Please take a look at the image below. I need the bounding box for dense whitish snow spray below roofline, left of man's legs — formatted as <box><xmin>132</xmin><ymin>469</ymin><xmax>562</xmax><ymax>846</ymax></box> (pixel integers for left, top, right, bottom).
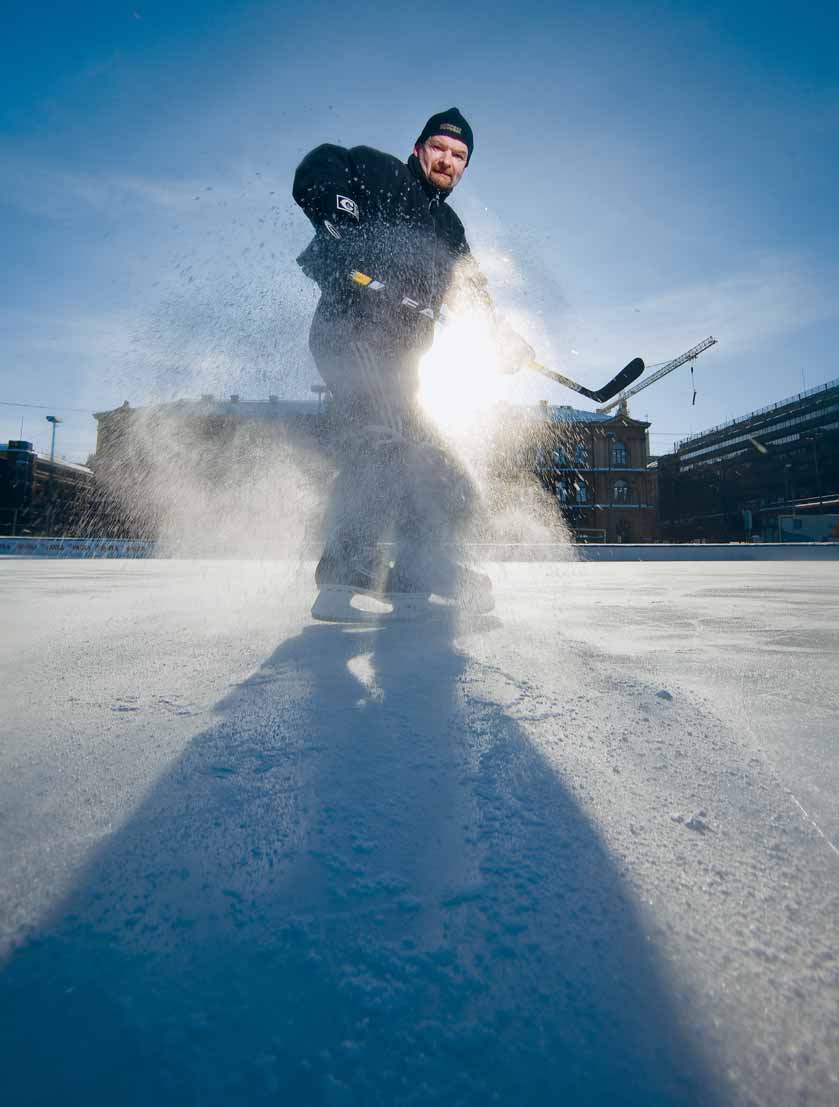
<box><xmin>90</xmin><ymin>400</ymin><xmax>323</xmax><ymax>558</ymax></box>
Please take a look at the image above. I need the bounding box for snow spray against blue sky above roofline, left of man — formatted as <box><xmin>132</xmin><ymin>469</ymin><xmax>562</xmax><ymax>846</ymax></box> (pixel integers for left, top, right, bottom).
<box><xmin>115</xmin><ymin>174</ymin><xmax>317</xmax><ymax>414</ymax></box>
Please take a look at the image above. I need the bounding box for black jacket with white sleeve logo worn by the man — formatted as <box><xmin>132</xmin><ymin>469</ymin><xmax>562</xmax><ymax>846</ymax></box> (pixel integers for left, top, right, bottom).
<box><xmin>293</xmin><ymin>144</ymin><xmax>485</xmax><ymax>352</ymax></box>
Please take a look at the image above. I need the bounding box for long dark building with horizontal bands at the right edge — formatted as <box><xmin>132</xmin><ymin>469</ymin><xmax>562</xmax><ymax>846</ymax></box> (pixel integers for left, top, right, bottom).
<box><xmin>657</xmin><ymin>381</ymin><xmax>839</xmax><ymax>541</ymax></box>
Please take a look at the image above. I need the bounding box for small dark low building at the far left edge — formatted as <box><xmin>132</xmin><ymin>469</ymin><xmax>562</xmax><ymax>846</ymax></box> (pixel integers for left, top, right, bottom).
<box><xmin>0</xmin><ymin>439</ymin><xmax>93</xmax><ymax>537</ymax></box>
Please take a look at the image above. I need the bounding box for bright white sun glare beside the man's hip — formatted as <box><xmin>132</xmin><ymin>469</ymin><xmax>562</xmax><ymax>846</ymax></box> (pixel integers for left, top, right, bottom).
<box><xmin>420</xmin><ymin>317</ymin><xmax>504</xmax><ymax>431</ymax></box>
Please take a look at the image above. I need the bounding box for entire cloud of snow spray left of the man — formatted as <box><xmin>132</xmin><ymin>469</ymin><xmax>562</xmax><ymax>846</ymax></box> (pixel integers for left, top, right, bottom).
<box><xmin>80</xmin><ymin>172</ymin><xmax>332</xmax><ymax>557</ymax></box>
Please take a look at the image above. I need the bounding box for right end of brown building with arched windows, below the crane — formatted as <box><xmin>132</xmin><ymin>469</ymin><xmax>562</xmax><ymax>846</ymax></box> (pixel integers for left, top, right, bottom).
<box><xmin>534</xmin><ymin>404</ymin><xmax>657</xmax><ymax>542</ymax></box>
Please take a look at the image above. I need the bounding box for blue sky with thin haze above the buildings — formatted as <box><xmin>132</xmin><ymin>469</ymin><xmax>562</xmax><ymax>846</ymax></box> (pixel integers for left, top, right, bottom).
<box><xmin>0</xmin><ymin>0</ymin><xmax>839</xmax><ymax>459</ymax></box>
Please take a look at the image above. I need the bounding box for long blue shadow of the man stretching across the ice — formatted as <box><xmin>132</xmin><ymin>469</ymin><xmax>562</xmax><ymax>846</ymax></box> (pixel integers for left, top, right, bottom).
<box><xmin>2</xmin><ymin>620</ymin><xmax>716</xmax><ymax>1107</ymax></box>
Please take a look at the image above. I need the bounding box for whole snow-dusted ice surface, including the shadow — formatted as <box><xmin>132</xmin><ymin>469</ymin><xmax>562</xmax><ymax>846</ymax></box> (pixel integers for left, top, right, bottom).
<box><xmin>0</xmin><ymin>560</ymin><xmax>839</xmax><ymax>1107</ymax></box>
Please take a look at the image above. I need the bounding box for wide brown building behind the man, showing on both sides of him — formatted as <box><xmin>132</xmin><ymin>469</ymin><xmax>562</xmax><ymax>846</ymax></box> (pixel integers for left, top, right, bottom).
<box><xmin>91</xmin><ymin>389</ymin><xmax>656</xmax><ymax>541</ymax></box>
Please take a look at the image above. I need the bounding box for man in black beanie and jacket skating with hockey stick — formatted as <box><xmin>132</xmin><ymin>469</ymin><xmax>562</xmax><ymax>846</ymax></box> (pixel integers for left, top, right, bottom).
<box><xmin>293</xmin><ymin>107</ymin><xmax>534</xmax><ymax>619</ymax></box>
